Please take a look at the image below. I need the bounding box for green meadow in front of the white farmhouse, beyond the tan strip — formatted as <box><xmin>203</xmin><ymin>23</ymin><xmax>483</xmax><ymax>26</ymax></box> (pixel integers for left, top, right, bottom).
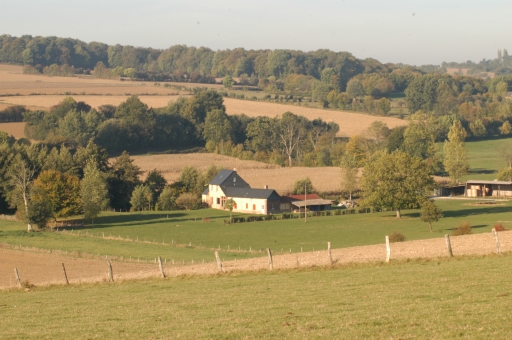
<box><xmin>0</xmin><ymin>200</ymin><xmax>512</xmax><ymax>261</ymax></box>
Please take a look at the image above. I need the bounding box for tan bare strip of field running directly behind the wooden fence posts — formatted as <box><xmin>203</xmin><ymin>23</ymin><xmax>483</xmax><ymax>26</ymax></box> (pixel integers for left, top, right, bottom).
<box><xmin>0</xmin><ymin>231</ymin><xmax>512</xmax><ymax>289</ymax></box>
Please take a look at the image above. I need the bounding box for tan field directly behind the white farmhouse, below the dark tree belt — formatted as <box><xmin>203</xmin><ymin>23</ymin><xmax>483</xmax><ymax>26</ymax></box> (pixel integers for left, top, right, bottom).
<box><xmin>126</xmin><ymin>153</ymin><xmax>341</xmax><ymax>194</ymax></box>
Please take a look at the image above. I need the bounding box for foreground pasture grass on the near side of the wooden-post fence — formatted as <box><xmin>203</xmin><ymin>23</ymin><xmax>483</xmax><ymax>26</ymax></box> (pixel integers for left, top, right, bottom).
<box><xmin>0</xmin><ymin>254</ymin><xmax>512</xmax><ymax>339</ymax></box>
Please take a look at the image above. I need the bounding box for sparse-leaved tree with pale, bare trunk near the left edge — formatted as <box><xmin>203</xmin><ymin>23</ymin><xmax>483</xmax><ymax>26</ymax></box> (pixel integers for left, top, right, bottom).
<box><xmin>8</xmin><ymin>159</ymin><xmax>36</xmax><ymax>232</ymax></box>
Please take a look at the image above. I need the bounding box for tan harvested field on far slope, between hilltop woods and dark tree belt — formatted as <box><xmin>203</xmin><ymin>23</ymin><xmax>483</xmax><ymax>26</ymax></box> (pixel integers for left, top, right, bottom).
<box><xmin>0</xmin><ymin>65</ymin><xmax>407</xmax><ymax>137</ymax></box>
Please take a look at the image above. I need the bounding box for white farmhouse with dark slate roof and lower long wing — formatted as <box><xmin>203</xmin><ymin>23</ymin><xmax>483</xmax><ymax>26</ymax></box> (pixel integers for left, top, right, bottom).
<box><xmin>202</xmin><ymin>170</ymin><xmax>280</xmax><ymax>215</ymax></box>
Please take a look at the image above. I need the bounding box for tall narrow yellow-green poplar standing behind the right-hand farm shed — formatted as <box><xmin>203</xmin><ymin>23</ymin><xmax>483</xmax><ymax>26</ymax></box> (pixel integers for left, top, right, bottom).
<box><xmin>443</xmin><ymin>120</ymin><xmax>469</xmax><ymax>183</ymax></box>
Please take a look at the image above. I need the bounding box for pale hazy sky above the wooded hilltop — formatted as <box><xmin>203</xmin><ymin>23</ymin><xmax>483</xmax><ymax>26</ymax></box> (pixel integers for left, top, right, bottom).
<box><xmin>0</xmin><ymin>0</ymin><xmax>512</xmax><ymax>65</ymax></box>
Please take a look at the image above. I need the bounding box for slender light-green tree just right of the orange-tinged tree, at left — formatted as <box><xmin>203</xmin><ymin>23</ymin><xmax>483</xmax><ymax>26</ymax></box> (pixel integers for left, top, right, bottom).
<box><xmin>80</xmin><ymin>158</ymin><xmax>108</xmax><ymax>226</ymax></box>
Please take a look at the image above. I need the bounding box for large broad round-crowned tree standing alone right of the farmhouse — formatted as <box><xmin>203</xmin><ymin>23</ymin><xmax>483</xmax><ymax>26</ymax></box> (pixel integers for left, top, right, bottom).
<box><xmin>360</xmin><ymin>151</ymin><xmax>435</xmax><ymax>218</ymax></box>
